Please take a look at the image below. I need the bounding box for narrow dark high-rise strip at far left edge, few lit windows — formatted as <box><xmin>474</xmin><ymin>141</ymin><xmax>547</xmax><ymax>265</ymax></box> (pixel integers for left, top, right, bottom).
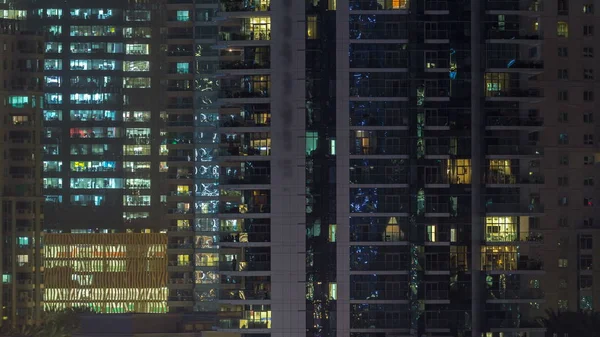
<box><xmin>0</xmin><ymin>5</ymin><xmax>44</xmax><ymax>328</ymax></box>
